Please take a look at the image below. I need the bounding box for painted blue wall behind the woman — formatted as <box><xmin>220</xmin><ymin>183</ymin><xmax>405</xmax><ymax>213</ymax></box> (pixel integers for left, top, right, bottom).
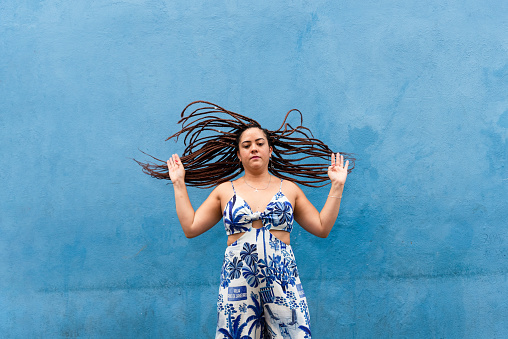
<box><xmin>0</xmin><ymin>0</ymin><xmax>508</xmax><ymax>338</ymax></box>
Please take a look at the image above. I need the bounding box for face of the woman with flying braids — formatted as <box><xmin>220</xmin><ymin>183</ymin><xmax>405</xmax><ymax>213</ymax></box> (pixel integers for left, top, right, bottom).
<box><xmin>237</xmin><ymin>127</ymin><xmax>272</xmax><ymax>169</ymax></box>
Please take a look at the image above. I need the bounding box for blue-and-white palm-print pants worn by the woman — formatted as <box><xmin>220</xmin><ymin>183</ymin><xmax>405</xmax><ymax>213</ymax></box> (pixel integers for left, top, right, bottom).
<box><xmin>215</xmin><ymin>227</ymin><xmax>311</xmax><ymax>339</ymax></box>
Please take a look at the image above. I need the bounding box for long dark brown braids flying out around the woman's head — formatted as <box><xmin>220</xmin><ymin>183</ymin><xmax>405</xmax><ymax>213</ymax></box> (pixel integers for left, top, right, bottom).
<box><xmin>135</xmin><ymin>101</ymin><xmax>356</xmax><ymax>188</ymax></box>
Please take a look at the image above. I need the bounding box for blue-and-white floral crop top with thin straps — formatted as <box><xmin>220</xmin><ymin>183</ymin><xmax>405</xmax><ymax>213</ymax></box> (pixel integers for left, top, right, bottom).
<box><xmin>222</xmin><ymin>179</ymin><xmax>293</xmax><ymax>235</ymax></box>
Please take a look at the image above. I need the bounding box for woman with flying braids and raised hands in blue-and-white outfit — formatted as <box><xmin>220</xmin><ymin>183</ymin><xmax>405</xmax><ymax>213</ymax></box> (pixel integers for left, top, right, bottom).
<box><xmin>141</xmin><ymin>102</ymin><xmax>354</xmax><ymax>339</ymax></box>
